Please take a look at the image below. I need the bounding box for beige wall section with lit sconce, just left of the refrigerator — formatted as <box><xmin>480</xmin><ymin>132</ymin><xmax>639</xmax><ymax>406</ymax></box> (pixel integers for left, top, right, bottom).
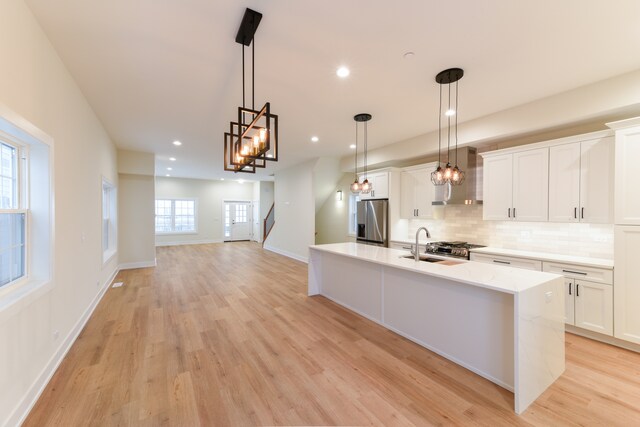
<box><xmin>316</xmin><ymin>173</ymin><xmax>355</xmax><ymax>245</ymax></box>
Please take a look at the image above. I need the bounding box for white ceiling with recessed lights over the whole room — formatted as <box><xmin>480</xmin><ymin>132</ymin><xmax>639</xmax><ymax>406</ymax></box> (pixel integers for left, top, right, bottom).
<box><xmin>26</xmin><ymin>0</ymin><xmax>640</xmax><ymax>179</ymax></box>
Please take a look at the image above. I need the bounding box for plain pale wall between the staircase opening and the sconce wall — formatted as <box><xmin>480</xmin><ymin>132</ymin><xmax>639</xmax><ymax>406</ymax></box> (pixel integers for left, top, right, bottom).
<box><xmin>264</xmin><ymin>160</ymin><xmax>316</xmax><ymax>262</ymax></box>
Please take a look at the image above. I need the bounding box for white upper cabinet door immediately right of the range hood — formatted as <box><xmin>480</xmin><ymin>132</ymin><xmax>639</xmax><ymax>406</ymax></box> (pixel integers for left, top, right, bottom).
<box><xmin>482</xmin><ymin>154</ymin><xmax>513</xmax><ymax>220</ymax></box>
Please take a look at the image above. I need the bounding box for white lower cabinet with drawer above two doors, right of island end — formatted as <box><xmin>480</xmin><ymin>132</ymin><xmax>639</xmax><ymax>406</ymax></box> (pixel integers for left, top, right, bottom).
<box><xmin>542</xmin><ymin>262</ymin><xmax>613</xmax><ymax>336</ymax></box>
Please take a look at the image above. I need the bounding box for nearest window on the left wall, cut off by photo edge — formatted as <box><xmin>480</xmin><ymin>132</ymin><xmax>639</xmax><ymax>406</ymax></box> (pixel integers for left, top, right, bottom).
<box><xmin>0</xmin><ymin>141</ymin><xmax>27</xmax><ymax>287</ymax></box>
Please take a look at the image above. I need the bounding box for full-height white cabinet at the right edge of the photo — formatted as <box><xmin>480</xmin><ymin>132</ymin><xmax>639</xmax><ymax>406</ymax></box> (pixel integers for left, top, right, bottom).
<box><xmin>607</xmin><ymin>117</ymin><xmax>640</xmax><ymax>344</ymax></box>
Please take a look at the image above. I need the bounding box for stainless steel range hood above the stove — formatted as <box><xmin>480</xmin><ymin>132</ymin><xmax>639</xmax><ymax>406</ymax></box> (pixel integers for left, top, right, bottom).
<box><xmin>432</xmin><ymin>147</ymin><xmax>482</xmax><ymax>206</ymax></box>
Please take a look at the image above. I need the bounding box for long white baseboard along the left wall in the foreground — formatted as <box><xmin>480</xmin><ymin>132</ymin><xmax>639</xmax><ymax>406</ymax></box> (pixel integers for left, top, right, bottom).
<box><xmin>5</xmin><ymin>268</ymin><xmax>119</xmax><ymax>426</ymax></box>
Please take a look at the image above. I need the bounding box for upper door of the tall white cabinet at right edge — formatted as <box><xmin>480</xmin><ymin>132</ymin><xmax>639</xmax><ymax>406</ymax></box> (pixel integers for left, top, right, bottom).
<box><xmin>615</xmin><ymin>126</ymin><xmax>640</xmax><ymax>225</ymax></box>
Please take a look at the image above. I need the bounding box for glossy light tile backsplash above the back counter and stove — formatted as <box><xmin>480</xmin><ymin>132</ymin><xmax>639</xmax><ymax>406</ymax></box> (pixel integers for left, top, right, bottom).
<box><xmin>407</xmin><ymin>205</ymin><xmax>613</xmax><ymax>259</ymax></box>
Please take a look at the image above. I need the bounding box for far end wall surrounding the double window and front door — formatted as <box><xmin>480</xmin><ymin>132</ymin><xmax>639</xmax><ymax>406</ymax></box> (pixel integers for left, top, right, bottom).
<box><xmin>155</xmin><ymin>177</ymin><xmax>253</xmax><ymax>246</ymax></box>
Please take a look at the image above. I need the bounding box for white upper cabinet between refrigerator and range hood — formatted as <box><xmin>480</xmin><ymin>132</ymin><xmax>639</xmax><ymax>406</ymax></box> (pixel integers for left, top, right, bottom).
<box><xmin>400</xmin><ymin>164</ymin><xmax>435</xmax><ymax>219</ymax></box>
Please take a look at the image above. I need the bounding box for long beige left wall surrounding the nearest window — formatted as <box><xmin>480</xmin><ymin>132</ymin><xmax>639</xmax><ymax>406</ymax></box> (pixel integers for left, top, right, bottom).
<box><xmin>0</xmin><ymin>0</ymin><xmax>118</xmax><ymax>426</ymax></box>
